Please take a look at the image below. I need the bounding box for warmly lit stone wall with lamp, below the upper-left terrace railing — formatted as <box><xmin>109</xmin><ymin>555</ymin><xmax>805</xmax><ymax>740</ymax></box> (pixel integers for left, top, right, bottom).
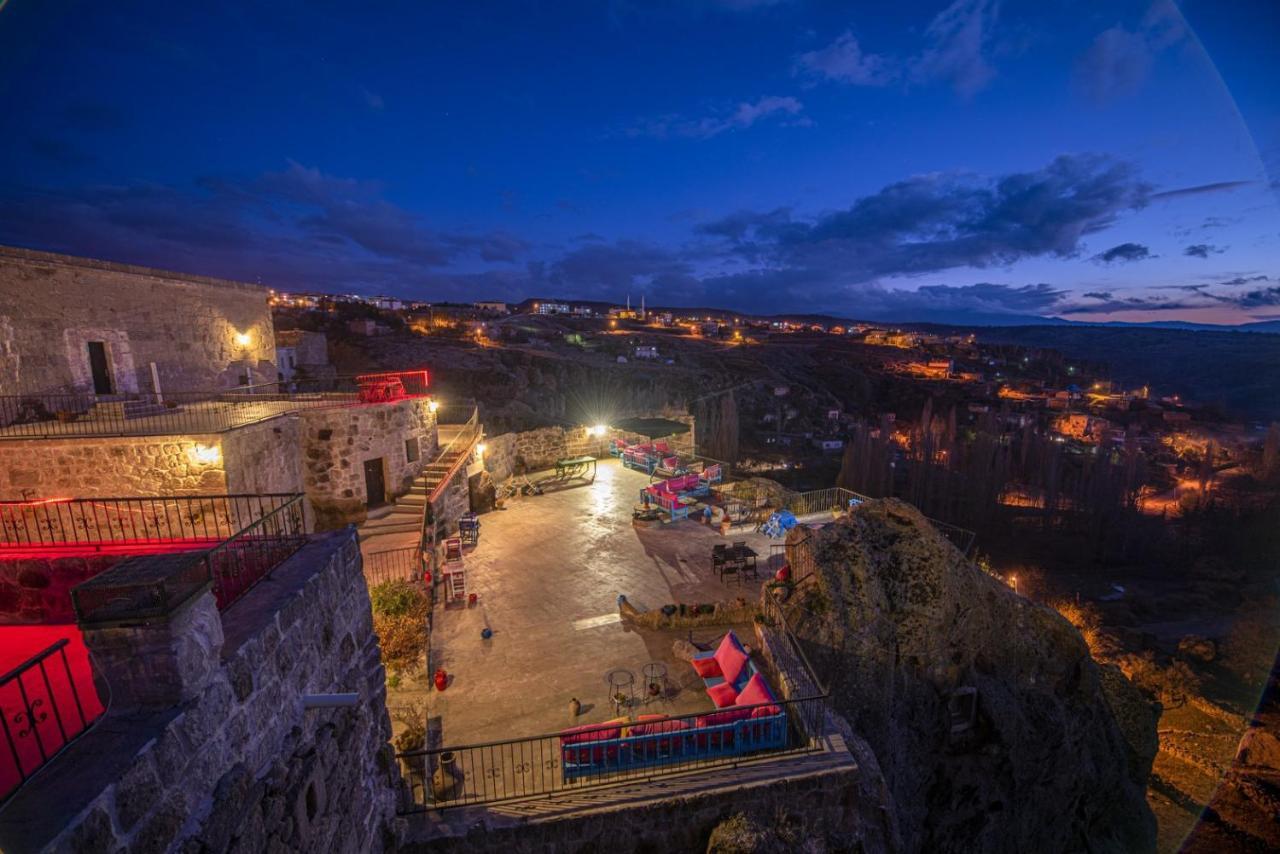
<box><xmin>0</xmin><ymin>435</ymin><xmax>227</xmax><ymax>499</ymax></box>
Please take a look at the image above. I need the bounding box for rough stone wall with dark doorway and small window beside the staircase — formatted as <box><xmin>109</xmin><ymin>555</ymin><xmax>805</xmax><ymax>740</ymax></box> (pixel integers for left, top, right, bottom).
<box><xmin>300</xmin><ymin>398</ymin><xmax>436</xmax><ymax>528</ymax></box>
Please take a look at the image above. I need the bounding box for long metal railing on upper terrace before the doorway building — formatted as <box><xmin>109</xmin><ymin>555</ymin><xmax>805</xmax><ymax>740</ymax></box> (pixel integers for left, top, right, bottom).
<box><xmin>0</xmin><ymin>371</ymin><xmax>428</xmax><ymax>439</ymax></box>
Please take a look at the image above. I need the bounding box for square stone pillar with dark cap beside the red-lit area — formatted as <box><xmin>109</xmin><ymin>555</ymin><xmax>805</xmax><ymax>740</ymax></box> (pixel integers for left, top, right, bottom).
<box><xmin>73</xmin><ymin>553</ymin><xmax>223</xmax><ymax>713</ymax></box>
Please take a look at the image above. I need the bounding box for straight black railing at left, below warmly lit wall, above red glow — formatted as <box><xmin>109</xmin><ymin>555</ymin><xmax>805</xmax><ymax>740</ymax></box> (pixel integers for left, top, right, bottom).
<box><xmin>0</xmin><ymin>494</ymin><xmax>297</xmax><ymax>556</ymax></box>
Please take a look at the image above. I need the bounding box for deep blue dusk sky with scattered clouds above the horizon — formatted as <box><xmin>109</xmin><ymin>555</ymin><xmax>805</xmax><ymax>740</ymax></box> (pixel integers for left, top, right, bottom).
<box><xmin>0</xmin><ymin>0</ymin><xmax>1280</xmax><ymax>321</ymax></box>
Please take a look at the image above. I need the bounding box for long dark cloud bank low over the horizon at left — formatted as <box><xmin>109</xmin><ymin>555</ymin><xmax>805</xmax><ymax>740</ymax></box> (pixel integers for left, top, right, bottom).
<box><xmin>0</xmin><ymin>163</ymin><xmax>530</xmax><ymax>289</ymax></box>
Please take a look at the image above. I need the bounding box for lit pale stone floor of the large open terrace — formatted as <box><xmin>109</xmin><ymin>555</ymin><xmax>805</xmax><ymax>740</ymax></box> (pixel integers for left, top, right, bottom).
<box><xmin>428</xmin><ymin>460</ymin><xmax>780</xmax><ymax>745</ymax></box>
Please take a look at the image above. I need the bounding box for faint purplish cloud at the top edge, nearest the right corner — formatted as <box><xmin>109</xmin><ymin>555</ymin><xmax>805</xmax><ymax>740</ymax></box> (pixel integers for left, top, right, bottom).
<box><xmin>1075</xmin><ymin>0</ymin><xmax>1187</xmax><ymax>104</ymax></box>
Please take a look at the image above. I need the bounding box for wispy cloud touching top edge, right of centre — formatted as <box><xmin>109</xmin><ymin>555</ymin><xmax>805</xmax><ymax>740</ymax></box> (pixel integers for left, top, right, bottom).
<box><xmin>910</xmin><ymin>0</ymin><xmax>1000</xmax><ymax>97</ymax></box>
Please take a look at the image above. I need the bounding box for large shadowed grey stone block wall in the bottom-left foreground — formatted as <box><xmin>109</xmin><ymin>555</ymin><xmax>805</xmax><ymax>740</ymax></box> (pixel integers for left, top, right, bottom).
<box><xmin>0</xmin><ymin>529</ymin><xmax>401</xmax><ymax>853</ymax></box>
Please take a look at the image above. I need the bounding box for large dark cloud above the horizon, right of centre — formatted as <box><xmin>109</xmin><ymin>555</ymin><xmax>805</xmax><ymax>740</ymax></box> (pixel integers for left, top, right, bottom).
<box><xmin>699</xmin><ymin>155</ymin><xmax>1149</xmax><ymax>286</ymax></box>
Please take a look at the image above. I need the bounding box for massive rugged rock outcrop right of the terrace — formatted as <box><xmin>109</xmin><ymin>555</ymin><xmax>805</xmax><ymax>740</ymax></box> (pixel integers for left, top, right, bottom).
<box><xmin>787</xmin><ymin>499</ymin><xmax>1156</xmax><ymax>851</ymax></box>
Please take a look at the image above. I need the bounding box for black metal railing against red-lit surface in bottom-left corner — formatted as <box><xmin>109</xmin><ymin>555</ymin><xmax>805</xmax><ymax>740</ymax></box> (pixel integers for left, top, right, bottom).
<box><xmin>0</xmin><ymin>638</ymin><xmax>102</xmax><ymax>803</ymax></box>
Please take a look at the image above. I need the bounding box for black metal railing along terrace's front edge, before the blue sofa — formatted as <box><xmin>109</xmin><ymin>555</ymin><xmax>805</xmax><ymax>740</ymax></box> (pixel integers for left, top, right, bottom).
<box><xmin>397</xmin><ymin>695</ymin><xmax>826</xmax><ymax>812</ymax></box>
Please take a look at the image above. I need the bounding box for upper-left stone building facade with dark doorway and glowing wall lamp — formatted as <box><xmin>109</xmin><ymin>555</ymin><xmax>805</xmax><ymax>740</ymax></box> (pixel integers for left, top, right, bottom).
<box><xmin>0</xmin><ymin>247</ymin><xmax>275</xmax><ymax>394</ymax></box>
